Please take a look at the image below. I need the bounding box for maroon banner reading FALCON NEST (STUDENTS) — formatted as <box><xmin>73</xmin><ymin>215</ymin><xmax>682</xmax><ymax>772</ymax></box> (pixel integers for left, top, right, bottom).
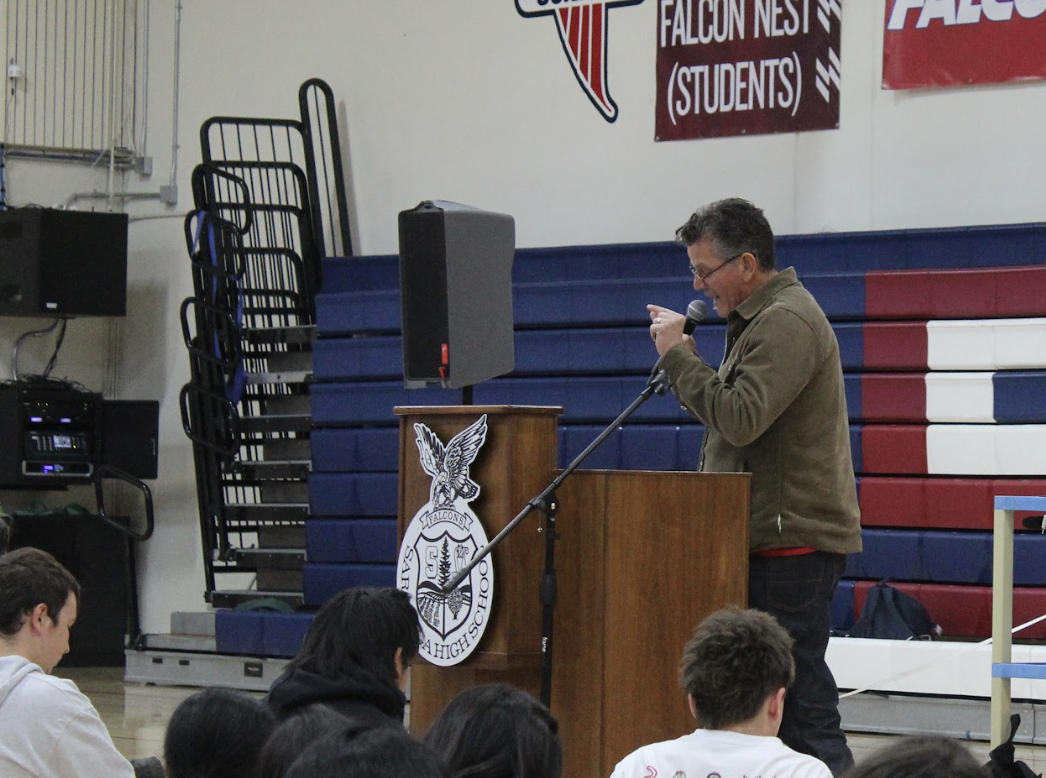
<box><xmin>654</xmin><ymin>0</ymin><xmax>842</xmax><ymax>140</ymax></box>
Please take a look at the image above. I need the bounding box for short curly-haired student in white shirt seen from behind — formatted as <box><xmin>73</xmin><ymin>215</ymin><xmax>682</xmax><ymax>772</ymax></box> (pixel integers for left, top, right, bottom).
<box><xmin>611</xmin><ymin>608</ymin><xmax>832</xmax><ymax>778</ymax></box>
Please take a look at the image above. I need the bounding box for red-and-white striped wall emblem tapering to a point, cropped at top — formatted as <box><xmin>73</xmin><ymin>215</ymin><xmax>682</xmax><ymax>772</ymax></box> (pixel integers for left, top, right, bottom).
<box><xmin>516</xmin><ymin>0</ymin><xmax>643</xmax><ymax>122</ymax></box>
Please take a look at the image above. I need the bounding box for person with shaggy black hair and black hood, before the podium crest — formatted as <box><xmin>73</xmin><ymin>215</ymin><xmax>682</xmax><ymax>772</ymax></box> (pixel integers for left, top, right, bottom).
<box><xmin>269</xmin><ymin>587</ymin><xmax>420</xmax><ymax>726</ymax></box>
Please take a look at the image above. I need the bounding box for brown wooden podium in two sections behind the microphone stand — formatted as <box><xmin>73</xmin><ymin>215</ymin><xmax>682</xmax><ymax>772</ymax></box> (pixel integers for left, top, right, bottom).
<box><xmin>395</xmin><ymin>406</ymin><xmax>749</xmax><ymax>778</ymax></box>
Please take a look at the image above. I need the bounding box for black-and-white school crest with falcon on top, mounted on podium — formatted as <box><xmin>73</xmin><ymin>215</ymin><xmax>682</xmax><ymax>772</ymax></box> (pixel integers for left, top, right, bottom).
<box><xmin>396</xmin><ymin>414</ymin><xmax>494</xmax><ymax>667</ymax></box>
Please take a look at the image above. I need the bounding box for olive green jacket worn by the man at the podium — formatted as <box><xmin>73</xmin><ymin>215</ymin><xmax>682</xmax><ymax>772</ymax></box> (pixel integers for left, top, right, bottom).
<box><xmin>661</xmin><ymin>268</ymin><xmax>861</xmax><ymax>553</ymax></box>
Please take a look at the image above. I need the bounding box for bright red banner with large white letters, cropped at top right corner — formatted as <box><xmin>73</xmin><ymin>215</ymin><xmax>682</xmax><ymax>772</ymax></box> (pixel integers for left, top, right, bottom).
<box><xmin>883</xmin><ymin>0</ymin><xmax>1046</xmax><ymax>89</ymax></box>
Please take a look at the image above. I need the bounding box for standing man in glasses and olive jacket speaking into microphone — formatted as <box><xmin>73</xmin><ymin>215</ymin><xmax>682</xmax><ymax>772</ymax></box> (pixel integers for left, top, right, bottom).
<box><xmin>646</xmin><ymin>199</ymin><xmax>861</xmax><ymax>775</ymax></box>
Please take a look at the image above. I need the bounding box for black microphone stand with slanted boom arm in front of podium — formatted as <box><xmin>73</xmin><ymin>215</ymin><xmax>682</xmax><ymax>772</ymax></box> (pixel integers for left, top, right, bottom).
<box><xmin>442</xmin><ymin>366</ymin><xmax>668</xmax><ymax>708</ymax></box>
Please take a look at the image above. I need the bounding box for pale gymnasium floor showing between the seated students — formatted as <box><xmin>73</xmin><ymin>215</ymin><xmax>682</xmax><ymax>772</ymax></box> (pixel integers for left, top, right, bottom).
<box><xmin>55</xmin><ymin>665</ymin><xmax>1046</xmax><ymax>773</ymax></box>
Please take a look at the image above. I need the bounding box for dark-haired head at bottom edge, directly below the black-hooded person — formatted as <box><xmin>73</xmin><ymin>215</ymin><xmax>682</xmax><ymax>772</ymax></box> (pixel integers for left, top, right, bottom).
<box><xmin>286</xmin><ymin>724</ymin><xmax>448</xmax><ymax>778</ymax></box>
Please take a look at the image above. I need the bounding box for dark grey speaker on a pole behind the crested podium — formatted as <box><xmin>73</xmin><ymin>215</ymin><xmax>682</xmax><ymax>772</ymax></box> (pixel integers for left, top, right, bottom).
<box><xmin>400</xmin><ymin>200</ymin><xmax>516</xmax><ymax>388</ymax></box>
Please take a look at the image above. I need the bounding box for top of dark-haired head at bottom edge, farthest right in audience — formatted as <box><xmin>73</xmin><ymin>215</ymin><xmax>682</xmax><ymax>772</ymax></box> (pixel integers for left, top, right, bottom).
<box><xmin>845</xmin><ymin>735</ymin><xmax>991</xmax><ymax>778</ymax></box>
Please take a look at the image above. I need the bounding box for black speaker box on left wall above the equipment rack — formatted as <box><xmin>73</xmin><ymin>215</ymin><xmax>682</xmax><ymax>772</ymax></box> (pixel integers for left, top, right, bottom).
<box><xmin>0</xmin><ymin>208</ymin><xmax>128</xmax><ymax>316</ymax></box>
